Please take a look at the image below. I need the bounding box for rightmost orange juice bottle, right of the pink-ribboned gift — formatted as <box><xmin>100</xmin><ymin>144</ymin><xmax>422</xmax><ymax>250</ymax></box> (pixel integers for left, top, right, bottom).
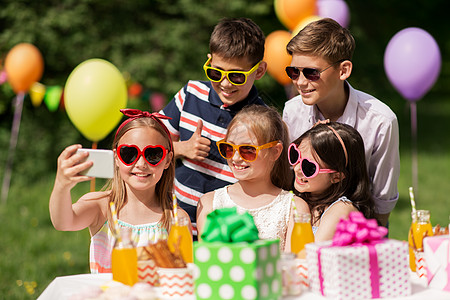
<box><xmin>408</xmin><ymin>210</ymin><xmax>433</xmax><ymax>272</ymax></box>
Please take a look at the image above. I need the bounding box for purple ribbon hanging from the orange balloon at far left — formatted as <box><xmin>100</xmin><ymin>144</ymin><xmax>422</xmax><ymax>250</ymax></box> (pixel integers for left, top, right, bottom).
<box><xmin>2</xmin><ymin>92</ymin><xmax>25</xmax><ymax>203</ymax></box>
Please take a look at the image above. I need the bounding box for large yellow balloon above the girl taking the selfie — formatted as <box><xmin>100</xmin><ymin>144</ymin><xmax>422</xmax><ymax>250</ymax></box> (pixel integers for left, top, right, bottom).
<box><xmin>64</xmin><ymin>59</ymin><xmax>127</xmax><ymax>142</ymax></box>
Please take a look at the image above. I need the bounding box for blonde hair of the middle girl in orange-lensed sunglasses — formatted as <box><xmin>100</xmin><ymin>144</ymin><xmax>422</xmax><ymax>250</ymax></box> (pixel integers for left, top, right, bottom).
<box><xmin>225</xmin><ymin>105</ymin><xmax>293</xmax><ymax>190</ymax></box>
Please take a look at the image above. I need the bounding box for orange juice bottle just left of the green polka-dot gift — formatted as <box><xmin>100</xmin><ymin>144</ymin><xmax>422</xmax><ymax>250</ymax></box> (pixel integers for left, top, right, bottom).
<box><xmin>167</xmin><ymin>217</ymin><xmax>194</xmax><ymax>263</ymax></box>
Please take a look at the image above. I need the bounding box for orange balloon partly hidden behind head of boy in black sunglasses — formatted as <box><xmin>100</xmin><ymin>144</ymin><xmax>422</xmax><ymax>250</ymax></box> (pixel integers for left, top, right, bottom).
<box><xmin>264</xmin><ymin>30</ymin><xmax>292</xmax><ymax>85</ymax></box>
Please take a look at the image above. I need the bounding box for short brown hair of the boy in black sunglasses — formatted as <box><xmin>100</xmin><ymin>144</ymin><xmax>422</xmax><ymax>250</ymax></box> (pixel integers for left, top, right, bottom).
<box><xmin>286</xmin><ymin>18</ymin><xmax>355</xmax><ymax>64</ymax></box>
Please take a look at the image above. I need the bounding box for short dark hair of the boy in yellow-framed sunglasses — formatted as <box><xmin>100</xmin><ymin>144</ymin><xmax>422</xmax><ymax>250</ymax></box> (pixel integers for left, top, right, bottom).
<box><xmin>209</xmin><ymin>18</ymin><xmax>265</xmax><ymax>65</ymax></box>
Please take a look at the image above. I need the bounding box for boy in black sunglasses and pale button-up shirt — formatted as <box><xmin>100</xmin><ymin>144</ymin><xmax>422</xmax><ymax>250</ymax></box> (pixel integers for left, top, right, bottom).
<box><xmin>283</xmin><ymin>18</ymin><xmax>400</xmax><ymax>226</ymax></box>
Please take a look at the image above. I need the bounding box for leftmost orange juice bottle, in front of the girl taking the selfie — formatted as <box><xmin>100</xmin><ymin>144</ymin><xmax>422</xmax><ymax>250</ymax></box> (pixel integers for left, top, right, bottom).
<box><xmin>111</xmin><ymin>228</ymin><xmax>138</xmax><ymax>286</ymax></box>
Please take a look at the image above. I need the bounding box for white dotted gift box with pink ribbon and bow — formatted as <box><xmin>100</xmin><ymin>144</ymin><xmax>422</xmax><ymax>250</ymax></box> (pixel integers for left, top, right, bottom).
<box><xmin>305</xmin><ymin>212</ymin><xmax>411</xmax><ymax>300</ymax></box>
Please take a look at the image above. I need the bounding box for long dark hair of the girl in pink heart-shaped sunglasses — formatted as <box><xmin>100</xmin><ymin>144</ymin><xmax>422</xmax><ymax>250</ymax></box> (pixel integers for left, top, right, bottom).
<box><xmin>294</xmin><ymin>122</ymin><xmax>375</xmax><ymax>221</ymax></box>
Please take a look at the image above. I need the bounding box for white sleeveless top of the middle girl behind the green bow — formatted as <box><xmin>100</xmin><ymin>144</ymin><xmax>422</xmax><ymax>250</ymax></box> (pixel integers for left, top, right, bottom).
<box><xmin>213</xmin><ymin>186</ymin><xmax>292</xmax><ymax>249</ymax></box>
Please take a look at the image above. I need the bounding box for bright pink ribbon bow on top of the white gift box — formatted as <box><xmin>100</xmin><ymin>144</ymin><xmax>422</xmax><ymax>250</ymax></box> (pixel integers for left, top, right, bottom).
<box><xmin>332</xmin><ymin>211</ymin><xmax>387</xmax><ymax>246</ymax></box>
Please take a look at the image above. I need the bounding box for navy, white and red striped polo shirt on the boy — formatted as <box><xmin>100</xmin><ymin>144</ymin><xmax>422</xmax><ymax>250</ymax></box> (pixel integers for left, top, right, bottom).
<box><xmin>161</xmin><ymin>81</ymin><xmax>265</xmax><ymax>235</ymax></box>
